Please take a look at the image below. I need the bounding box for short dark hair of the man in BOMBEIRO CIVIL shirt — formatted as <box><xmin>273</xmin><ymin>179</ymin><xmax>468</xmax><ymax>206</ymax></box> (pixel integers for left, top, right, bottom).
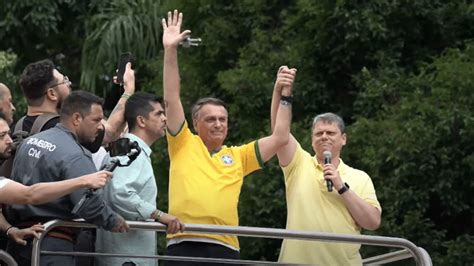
<box><xmin>59</xmin><ymin>91</ymin><xmax>104</xmax><ymax>120</ymax></box>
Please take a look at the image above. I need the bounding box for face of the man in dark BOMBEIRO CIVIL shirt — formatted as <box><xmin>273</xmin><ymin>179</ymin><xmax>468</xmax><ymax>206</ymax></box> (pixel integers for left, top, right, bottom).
<box><xmin>76</xmin><ymin>104</ymin><xmax>104</xmax><ymax>143</ymax></box>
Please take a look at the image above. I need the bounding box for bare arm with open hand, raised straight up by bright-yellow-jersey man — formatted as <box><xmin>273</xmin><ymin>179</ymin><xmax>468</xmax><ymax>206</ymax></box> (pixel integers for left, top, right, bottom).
<box><xmin>162</xmin><ymin>10</ymin><xmax>191</xmax><ymax>135</ymax></box>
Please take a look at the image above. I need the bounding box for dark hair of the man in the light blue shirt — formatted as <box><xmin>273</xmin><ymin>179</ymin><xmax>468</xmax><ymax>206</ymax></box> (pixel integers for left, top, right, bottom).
<box><xmin>125</xmin><ymin>92</ymin><xmax>164</xmax><ymax>131</ymax></box>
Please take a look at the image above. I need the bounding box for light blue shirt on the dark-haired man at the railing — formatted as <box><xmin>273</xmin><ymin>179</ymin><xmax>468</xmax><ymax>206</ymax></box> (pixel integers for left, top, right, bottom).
<box><xmin>96</xmin><ymin>134</ymin><xmax>158</xmax><ymax>266</ymax></box>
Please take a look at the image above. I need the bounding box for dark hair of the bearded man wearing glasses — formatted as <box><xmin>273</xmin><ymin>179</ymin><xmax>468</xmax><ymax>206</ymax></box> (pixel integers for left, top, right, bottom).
<box><xmin>20</xmin><ymin>59</ymin><xmax>55</xmax><ymax>106</ymax></box>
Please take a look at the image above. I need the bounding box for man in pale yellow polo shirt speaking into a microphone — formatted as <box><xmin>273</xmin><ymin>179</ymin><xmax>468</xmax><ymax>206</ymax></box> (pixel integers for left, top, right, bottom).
<box><xmin>271</xmin><ymin>84</ymin><xmax>382</xmax><ymax>265</ymax></box>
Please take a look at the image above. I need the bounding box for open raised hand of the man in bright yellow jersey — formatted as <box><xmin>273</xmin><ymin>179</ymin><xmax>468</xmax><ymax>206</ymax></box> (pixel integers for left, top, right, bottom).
<box><xmin>161</xmin><ymin>9</ymin><xmax>191</xmax><ymax>48</ymax></box>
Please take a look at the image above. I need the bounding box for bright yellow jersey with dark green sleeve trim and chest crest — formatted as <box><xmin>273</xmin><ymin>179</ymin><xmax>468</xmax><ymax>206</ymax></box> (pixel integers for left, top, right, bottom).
<box><xmin>167</xmin><ymin>122</ymin><xmax>263</xmax><ymax>249</ymax></box>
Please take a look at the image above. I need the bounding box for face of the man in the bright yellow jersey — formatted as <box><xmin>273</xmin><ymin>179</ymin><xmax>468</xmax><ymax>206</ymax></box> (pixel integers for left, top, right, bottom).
<box><xmin>193</xmin><ymin>104</ymin><xmax>228</xmax><ymax>148</ymax></box>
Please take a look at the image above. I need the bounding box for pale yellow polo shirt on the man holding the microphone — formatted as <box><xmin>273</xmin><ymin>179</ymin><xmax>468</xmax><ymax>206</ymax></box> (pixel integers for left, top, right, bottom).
<box><xmin>279</xmin><ymin>144</ymin><xmax>381</xmax><ymax>265</ymax></box>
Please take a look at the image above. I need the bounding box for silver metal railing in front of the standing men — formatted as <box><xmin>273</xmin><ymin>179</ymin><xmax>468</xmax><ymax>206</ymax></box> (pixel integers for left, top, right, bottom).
<box><xmin>31</xmin><ymin>220</ymin><xmax>432</xmax><ymax>266</ymax></box>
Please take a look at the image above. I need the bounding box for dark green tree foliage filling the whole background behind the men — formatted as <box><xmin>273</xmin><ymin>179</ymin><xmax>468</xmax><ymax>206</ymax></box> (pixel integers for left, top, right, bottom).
<box><xmin>0</xmin><ymin>0</ymin><xmax>474</xmax><ymax>265</ymax></box>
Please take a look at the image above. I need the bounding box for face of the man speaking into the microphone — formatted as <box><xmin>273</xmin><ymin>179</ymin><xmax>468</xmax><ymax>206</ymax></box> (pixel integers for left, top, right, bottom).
<box><xmin>311</xmin><ymin>121</ymin><xmax>346</xmax><ymax>157</ymax></box>
